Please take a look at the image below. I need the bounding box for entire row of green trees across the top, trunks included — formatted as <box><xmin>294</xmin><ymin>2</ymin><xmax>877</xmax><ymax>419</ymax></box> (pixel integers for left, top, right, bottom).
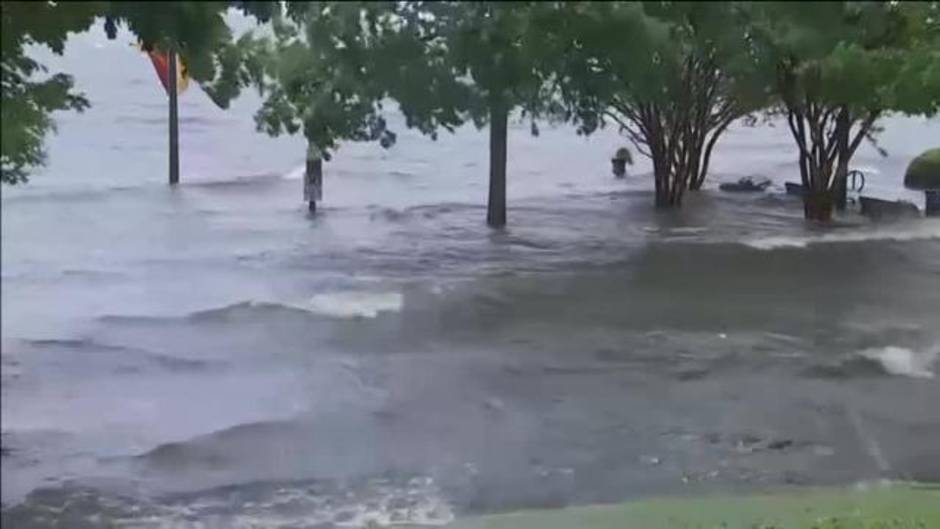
<box><xmin>2</xmin><ymin>1</ymin><xmax>940</xmax><ymax>226</ymax></box>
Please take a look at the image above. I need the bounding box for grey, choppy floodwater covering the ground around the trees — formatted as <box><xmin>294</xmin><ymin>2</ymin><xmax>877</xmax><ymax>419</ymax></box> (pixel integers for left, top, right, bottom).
<box><xmin>2</xmin><ymin>21</ymin><xmax>940</xmax><ymax>528</ymax></box>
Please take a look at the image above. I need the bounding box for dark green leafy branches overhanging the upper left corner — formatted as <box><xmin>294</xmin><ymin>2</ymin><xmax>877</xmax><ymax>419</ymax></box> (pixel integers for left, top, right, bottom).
<box><xmin>0</xmin><ymin>2</ymin><xmax>277</xmax><ymax>183</ymax></box>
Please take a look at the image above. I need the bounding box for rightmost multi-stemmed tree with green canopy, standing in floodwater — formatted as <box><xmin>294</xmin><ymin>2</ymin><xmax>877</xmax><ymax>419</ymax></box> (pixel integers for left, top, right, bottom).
<box><xmin>748</xmin><ymin>2</ymin><xmax>940</xmax><ymax>220</ymax></box>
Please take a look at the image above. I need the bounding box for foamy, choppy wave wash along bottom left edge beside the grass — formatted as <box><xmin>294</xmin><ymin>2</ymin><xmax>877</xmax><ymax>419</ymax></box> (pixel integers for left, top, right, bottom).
<box><xmin>4</xmin><ymin>476</ymin><xmax>454</xmax><ymax>529</ymax></box>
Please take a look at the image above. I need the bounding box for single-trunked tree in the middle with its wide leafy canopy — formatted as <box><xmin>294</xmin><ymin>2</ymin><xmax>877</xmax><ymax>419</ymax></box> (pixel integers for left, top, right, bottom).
<box><xmin>215</xmin><ymin>2</ymin><xmax>560</xmax><ymax>225</ymax></box>
